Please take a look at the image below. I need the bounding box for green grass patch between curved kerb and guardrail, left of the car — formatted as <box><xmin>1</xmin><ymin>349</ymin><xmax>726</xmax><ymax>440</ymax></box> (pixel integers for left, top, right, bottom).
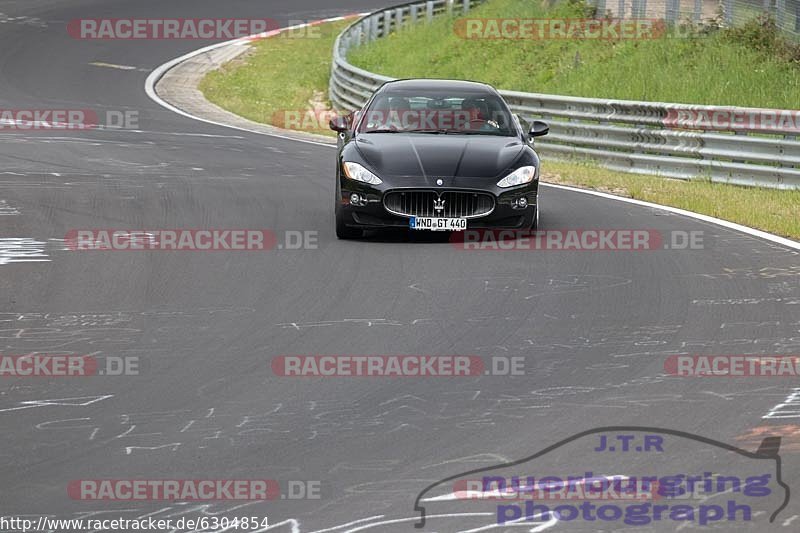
<box><xmin>200</xmin><ymin>21</ymin><xmax>349</xmax><ymax>135</ymax></box>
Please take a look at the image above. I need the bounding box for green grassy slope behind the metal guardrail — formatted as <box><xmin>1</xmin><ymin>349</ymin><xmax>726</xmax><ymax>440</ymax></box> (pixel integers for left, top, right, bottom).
<box><xmin>349</xmin><ymin>0</ymin><xmax>800</xmax><ymax>109</ymax></box>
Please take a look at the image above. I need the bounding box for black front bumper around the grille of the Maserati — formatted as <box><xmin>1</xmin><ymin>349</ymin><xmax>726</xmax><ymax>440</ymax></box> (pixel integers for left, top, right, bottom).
<box><xmin>338</xmin><ymin>178</ymin><xmax>539</xmax><ymax>229</ymax></box>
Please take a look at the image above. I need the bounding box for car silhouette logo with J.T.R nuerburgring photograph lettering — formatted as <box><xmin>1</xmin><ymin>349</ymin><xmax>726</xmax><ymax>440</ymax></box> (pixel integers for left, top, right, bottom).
<box><xmin>414</xmin><ymin>426</ymin><xmax>790</xmax><ymax>531</ymax></box>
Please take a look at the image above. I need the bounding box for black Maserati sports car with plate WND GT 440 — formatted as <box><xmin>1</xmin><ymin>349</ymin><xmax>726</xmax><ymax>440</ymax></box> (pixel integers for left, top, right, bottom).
<box><xmin>330</xmin><ymin>79</ymin><xmax>549</xmax><ymax>239</ymax></box>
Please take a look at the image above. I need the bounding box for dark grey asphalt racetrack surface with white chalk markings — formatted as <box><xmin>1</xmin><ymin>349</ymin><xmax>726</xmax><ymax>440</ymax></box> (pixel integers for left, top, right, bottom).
<box><xmin>0</xmin><ymin>0</ymin><xmax>800</xmax><ymax>533</ymax></box>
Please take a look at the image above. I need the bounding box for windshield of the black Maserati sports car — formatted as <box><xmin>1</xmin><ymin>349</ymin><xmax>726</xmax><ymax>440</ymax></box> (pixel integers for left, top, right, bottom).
<box><xmin>358</xmin><ymin>91</ymin><xmax>516</xmax><ymax>136</ymax></box>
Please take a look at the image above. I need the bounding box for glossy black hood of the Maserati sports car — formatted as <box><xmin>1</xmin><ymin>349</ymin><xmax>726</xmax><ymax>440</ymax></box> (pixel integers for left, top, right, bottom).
<box><xmin>355</xmin><ymin>133</ymin><xmax>525</xmax><ymax>180</ymax></box>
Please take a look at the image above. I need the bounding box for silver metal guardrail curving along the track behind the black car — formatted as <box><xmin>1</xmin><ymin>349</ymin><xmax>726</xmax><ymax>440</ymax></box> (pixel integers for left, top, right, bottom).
<box><xmin>329</xmin><ymin>0</ymin><xmax>800</xmax><ymax>189</ymax></box>
